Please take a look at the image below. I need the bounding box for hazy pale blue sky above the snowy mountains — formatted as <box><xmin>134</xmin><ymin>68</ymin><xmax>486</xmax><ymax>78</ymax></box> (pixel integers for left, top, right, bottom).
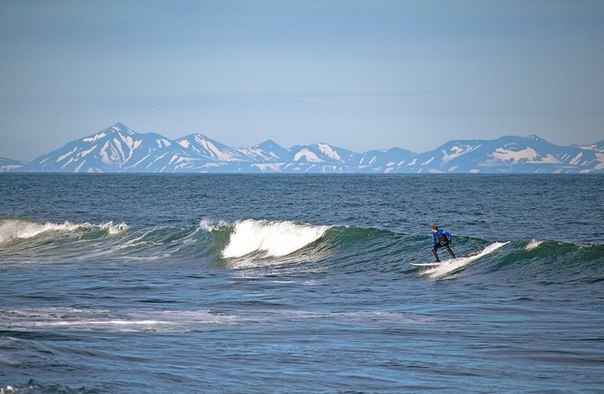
<box><xmin>0</xmin><ymin>0</ymin><xmax>604</xmax><ymax>161</ymax></box>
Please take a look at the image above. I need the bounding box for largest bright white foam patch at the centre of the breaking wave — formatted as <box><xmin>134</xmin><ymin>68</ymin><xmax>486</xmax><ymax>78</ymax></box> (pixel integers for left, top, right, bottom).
<box><xmin>222</xmin><ymin>219</ymin><xmax>329</xmax><ymax>258</ymax></box>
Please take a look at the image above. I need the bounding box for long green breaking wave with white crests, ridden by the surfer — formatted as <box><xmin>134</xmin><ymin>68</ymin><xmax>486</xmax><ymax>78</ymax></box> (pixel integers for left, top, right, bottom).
<box><xmin>0</xmin><ymin>218</ymin><xmax>604</xmax><ymax>281</ymax></box>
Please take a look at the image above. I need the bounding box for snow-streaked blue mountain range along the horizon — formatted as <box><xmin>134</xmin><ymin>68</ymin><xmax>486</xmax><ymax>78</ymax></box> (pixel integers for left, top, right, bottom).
<box><xmin>0</xmin><ymin>123</ymin><xmax>604</xmax><ymax>174</ymax></box>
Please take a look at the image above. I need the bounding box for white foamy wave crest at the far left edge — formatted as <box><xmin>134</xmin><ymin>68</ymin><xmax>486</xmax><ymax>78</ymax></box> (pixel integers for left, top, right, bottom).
<box><xmin>0</xmin><ymin>219</ymin><xmax>129</xmax><ymax>244</ymax></box>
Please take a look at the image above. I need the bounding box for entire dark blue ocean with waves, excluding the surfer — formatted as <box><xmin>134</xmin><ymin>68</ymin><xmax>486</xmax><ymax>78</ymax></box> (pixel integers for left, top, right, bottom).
<box><xmin>0</xmin><ymin>174</ymin><xmax>604</xmax><ymax>393</ymax></box>
